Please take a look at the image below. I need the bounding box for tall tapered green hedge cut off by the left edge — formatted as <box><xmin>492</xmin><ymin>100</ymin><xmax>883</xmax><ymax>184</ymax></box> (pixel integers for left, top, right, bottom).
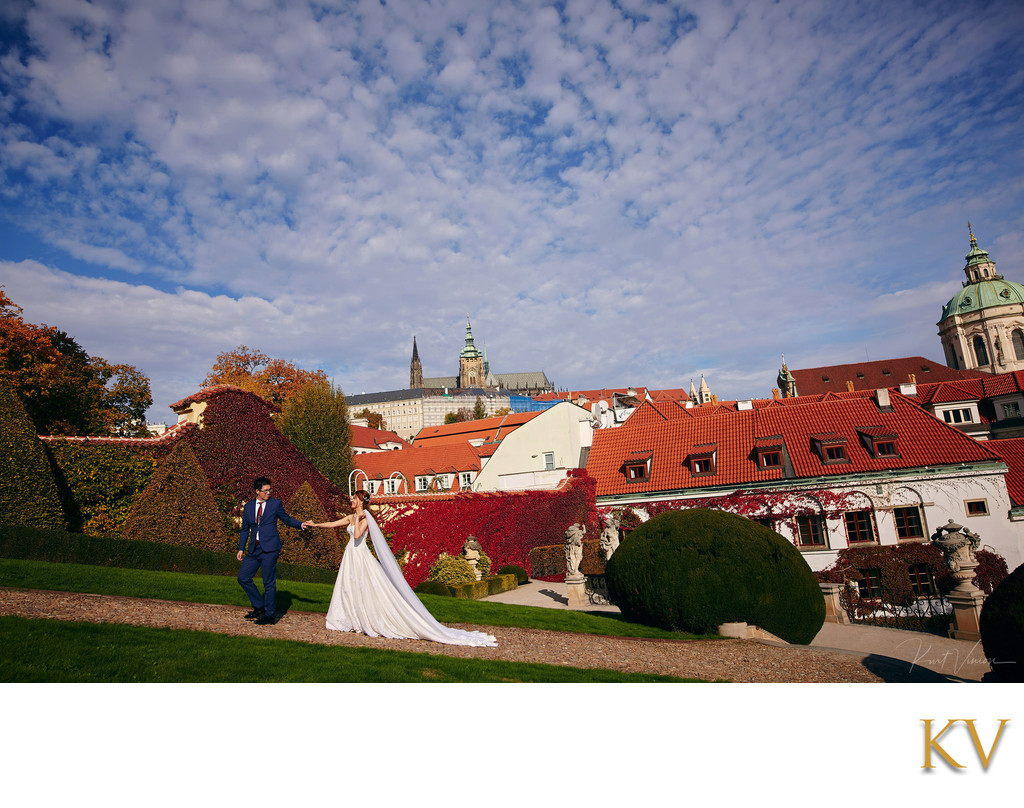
<box><xmin>0</xmin><ymin>379</ymin><xmax>68</xmax><ymax>528</ymax></box>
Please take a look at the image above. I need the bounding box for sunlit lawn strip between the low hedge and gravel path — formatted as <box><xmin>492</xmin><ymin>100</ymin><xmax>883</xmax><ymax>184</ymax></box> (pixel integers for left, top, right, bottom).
<box><xmin>0</xmin><ymin>558</ymin><xmax>712</xmax><ymax>640</ymax></box>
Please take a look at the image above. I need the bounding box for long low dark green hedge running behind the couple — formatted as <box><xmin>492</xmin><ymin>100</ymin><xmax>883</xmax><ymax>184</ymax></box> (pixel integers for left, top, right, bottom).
<box><xmin>0</xmin><ymin>524</ymin><xmax>337</xmax><ymax>584</ymax></box>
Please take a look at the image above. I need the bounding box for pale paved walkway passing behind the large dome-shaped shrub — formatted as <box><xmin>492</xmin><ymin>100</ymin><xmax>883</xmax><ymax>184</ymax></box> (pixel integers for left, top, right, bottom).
<box><xmin>486</xmin><ymin>581</ymin><xmax>991</xmax><ymax>682</ymax></box>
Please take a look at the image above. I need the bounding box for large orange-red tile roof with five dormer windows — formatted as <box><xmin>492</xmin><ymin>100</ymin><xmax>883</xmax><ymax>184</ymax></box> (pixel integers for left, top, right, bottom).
<box><xmin>587</xmin><ymin>392</ymin><xmax>998</xmax><ymax>496</ymax></box>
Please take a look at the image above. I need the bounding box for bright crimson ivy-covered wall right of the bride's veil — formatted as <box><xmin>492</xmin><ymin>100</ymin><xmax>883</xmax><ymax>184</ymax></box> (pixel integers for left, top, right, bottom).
<box><xmin>378</xmin><ymin>469</ymin><xmax>599</xmax><ymax>587</ymax></box>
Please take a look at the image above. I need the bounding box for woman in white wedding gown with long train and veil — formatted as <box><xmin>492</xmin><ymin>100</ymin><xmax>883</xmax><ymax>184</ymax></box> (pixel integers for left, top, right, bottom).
<box><xmin>302</xmin><ymin>490</ymin><xmax>498</xmax><ymax>646</ymax></box>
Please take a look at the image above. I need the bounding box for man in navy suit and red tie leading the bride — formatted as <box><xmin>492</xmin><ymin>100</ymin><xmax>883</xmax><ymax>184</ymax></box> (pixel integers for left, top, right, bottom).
<box><xmin>238</xmin><ymin>477</ymin><xmax>305</xmax><ymax>626</ymax></box>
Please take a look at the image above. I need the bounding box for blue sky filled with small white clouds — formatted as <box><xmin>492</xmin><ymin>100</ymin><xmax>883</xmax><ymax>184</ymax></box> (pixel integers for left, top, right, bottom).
<box><xmin>0</xmin><ymin>0</ymin><xmax>1024</xmax><ymax>420</ymax></box>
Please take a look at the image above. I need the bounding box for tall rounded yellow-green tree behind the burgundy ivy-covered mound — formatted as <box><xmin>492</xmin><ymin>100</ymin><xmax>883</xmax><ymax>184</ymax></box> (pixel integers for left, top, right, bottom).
<box><xmin>278</xmin><ymin>381</ymin><xmax>352</xmax><ymax>490</ymax></box>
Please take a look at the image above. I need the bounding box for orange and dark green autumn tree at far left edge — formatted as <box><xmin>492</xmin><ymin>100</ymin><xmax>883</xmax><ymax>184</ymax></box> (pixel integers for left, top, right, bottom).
<box><xmin>0</xmin><ymin>289</ymin><xmax>153</xmax><ymax>435</ymax></box>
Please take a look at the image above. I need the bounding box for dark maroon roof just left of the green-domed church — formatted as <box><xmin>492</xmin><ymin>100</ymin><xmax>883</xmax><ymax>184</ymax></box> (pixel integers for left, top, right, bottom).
<box><xmin>790</xmin><ymin>356</ymin><xmax>990</xmax><ymax>395</ymax></box>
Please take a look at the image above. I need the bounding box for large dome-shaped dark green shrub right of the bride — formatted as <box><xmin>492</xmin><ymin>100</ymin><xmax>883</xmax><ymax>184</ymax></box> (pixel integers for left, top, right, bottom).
<box><xmin>605</xmin><ymin>508</ymin><xmax>825</xmax><ymax>645</ymax></box>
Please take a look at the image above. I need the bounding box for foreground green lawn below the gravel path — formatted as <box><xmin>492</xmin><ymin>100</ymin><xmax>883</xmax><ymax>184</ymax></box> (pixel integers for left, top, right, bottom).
<box><xmin>0</xmin><ymin>616</ymin><xmax>700</xmax><ymax>683</ymax></box>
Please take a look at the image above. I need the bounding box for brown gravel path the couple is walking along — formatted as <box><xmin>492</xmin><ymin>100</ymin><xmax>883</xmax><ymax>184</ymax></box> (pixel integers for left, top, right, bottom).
<box><xmin>0</xmin><ymin>587</ymin><xmax>884</xmax><ymax>682</ymax></box>
